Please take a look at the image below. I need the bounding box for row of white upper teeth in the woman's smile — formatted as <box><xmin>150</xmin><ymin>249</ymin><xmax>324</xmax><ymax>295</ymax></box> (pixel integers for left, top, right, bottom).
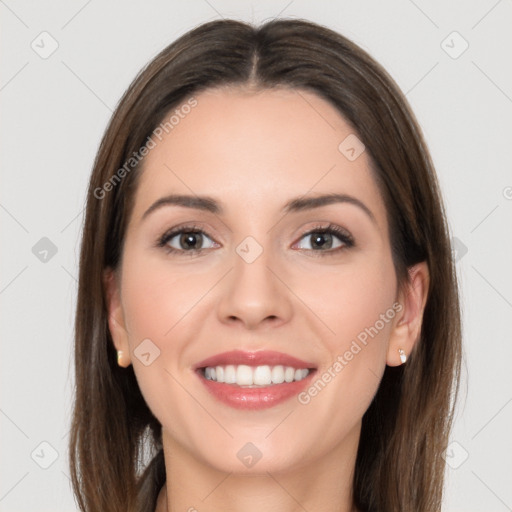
<box><xmin>204</xmin><ymin>364</ymin><xmax>309</xmax><ymax>387</ymax></box>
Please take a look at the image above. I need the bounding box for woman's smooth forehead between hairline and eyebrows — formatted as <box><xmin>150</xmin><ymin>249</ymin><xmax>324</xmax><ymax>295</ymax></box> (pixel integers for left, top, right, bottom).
<box><xmin>130</xmin><ymin>88</ymin><xmax>385</xmax><ymax>226</ymax></box>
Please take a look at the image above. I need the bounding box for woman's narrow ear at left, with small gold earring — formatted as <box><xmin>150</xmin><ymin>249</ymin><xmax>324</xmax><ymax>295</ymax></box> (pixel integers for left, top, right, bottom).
<box><xmin>103</xmin><ymin>268</ymin><xmax>131</xmax><ymax>368</ymax></box>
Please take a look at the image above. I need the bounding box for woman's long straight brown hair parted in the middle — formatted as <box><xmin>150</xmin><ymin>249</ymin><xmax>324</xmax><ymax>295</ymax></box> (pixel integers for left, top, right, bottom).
<box><xmin>70</xmin><ymin>19</ymin><xmax>461</xmax><ymax>512</ymax></box>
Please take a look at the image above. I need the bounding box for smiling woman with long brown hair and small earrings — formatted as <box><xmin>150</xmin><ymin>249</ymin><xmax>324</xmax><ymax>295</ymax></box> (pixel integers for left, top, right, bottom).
<box><xmin>70</xmin><ymin>20</ymin><xmax>461</xmax><ymax>512</ymax></box>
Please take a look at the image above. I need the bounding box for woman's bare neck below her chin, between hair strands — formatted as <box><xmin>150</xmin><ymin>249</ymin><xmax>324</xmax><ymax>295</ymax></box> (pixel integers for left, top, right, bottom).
<box><xmin>156</xmin><ymin>428</ymin><xmax>359</xmax><ymax>512</ymax></box>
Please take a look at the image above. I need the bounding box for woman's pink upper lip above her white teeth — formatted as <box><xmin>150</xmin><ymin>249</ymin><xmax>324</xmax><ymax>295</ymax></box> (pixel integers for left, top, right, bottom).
<box><xmin>194</xmin><ymin>350</ymin><xmax>316</xmax><ymax>370</ymax></box>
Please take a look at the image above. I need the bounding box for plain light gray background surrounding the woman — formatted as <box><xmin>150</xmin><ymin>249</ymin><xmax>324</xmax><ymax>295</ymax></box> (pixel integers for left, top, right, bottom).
<box><xmin>0</xmin><ymin>0</ymin><xmax>512</xmax><ymax>512</ymax></box>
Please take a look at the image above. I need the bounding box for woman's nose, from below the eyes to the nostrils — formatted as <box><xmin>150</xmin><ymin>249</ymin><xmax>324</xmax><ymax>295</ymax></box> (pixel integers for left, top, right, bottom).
<box><xmin>217</xmin><ymin>242</ymin><xmax>293</xmax><ymax>330</ymax></box>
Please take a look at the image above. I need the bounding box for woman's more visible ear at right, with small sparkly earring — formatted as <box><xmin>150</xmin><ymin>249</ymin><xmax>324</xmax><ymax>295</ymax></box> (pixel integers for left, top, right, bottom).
<box><xmin>386</xmin><ymin>261</ymin><xmax>430</xmax><ymax>366</ymax></box>
